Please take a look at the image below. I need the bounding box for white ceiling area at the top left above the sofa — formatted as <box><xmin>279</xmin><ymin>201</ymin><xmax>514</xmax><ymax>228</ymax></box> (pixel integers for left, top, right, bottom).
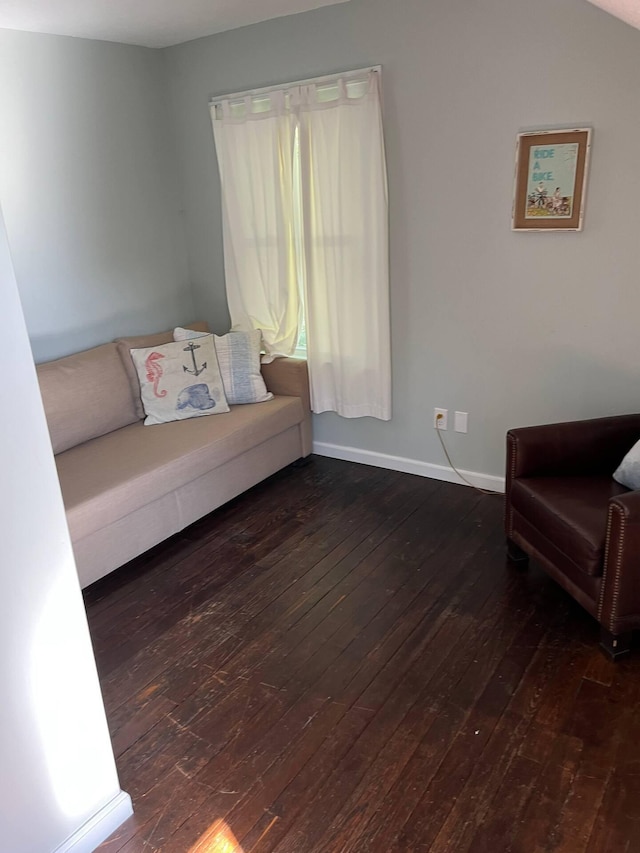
<box><xmin>0</xmin><ymin>0</ymin><xmax>347</xmax><ymax>47</ymax></box>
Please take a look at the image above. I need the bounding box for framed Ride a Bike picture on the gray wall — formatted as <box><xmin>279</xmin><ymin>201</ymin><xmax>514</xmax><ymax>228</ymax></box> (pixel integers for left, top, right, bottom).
<box><xmin>511</xmin><ymin>128</ymin><xmax>591</xmax><ymax>231</ymax></box>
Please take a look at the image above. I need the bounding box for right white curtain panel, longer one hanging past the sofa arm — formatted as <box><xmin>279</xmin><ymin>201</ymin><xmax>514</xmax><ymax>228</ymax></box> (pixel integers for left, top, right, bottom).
<box><xmin>300</xmin><ymin>72</ymin><xmax>391</xmax><ymax>420</ymax></box>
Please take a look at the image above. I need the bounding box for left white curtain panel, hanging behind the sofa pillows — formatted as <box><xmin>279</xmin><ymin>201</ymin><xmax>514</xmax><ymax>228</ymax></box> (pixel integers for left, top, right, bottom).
<box><xmin>211</xmin><ymin>92</ymin><xmax>302</xmax><ymax>361</ymax></box>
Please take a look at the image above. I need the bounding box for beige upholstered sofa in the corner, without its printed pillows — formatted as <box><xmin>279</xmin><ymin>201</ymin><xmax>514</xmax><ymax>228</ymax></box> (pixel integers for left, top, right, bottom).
<box><xmin>37</xmin><ymin>324</ymin><xmax>311</xmax><ymax>587</ymax></box>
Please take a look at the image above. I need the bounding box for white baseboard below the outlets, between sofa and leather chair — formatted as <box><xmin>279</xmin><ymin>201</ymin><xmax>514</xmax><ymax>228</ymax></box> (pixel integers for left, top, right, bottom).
<box><xmin>313</xmin><ymin>441</ymin><xmax>505</xmax><ymax>492</ymax></box>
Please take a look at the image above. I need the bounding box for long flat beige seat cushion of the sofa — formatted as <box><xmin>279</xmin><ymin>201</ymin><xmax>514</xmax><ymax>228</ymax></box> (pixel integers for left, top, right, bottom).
<box><xmin>56</xmin><ymin>397</ymin><xmax>304</xmax><ymax>541</ymax></box>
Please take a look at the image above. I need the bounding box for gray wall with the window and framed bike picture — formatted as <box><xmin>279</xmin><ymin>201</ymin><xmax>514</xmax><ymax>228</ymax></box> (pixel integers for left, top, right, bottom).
<box><xmin>165</xmin><ymin>0</ymin><xmax>640</xmax><ymax>475</ymax></box>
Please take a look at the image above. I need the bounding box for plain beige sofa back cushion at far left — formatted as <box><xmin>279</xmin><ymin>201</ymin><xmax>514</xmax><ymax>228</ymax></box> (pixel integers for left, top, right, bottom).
<box><xmin>36</xmin><ymin>344</ymin><xmax>138</xmax><ymax>453</ymax></box>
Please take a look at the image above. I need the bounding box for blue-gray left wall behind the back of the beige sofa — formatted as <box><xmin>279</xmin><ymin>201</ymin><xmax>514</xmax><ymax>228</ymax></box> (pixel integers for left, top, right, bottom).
<box><xmin>0</xmin><ymin>30</ymin><xmax>192</xmax><ymax>361</ymax></box>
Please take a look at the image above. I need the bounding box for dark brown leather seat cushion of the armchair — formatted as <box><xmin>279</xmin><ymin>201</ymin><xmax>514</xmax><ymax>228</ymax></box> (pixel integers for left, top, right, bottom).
<box><xmin>511</xmin><ymin>476</ymin><xmax>628</xmax><ymax>577</ymax></box>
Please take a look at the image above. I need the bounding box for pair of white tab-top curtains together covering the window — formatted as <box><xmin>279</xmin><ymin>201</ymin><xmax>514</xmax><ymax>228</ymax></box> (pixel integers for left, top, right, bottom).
<box><xmin>211</xmin><ymin>71</ymin><xmax>391</xmax><ymax>420</ymax></box>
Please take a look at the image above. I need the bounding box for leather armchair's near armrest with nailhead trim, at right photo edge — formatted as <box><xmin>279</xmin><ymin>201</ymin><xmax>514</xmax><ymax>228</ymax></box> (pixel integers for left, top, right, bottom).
<box><xmin>598</xmin><ymin>491</ymin><xmax>640</xmax><ymax>634</ymax></box>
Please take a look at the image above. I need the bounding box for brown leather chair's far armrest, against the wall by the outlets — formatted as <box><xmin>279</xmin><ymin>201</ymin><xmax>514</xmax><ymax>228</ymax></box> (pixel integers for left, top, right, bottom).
<box><xmin>507</xmin><ymin>414</ymin><xmax>640</xmax><ymax>483</ymax></box>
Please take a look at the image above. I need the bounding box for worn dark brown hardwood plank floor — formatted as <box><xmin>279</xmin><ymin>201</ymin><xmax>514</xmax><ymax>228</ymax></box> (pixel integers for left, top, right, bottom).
<box><xmin>86</xmin><ymin>458</ymin><xmax>640</xmax><ymax>853</ymax></box>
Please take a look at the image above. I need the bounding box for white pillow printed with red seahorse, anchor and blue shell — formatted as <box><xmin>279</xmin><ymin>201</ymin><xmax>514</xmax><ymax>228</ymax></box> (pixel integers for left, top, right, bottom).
<box><xmin>131</xmin><ymin>335</ymin><xmax>229</xmax><ymax>426</ymax></box>
